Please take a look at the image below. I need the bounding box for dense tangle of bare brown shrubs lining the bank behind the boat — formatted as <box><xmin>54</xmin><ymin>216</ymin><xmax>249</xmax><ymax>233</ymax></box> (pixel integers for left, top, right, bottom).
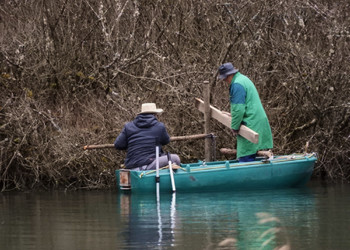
<box><xmin>0</xmin><ymin>0</ymin><xmax>350</xmax><ymax>190</ymax></box>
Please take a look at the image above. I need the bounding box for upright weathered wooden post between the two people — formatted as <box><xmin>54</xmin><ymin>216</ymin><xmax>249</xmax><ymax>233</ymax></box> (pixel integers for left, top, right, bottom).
<box><xmin>203</xmin><ymin>81</ymin><xmax>211</xmax><ymax>162</ymax></box>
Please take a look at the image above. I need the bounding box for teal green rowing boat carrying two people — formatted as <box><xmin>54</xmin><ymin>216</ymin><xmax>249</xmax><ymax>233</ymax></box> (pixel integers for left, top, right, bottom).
<box><xmin>116</xmin><ymin>153</ymin><xmax>317</xmax><ymax>193</ymax></box>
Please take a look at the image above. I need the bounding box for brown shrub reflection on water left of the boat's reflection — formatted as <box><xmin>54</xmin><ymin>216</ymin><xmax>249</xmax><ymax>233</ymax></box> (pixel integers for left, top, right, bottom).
<box><xmin>0</xmin><ymin>191</ymin><xmax>121</xmax><ymax>250</ymax></box>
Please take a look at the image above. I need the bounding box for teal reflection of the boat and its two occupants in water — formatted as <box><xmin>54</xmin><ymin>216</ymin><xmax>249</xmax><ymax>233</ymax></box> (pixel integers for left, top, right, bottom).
<box><xmin>119</xmin><ymin>188</ymin><xmax>317</xmax><ymax>249</ymax></box>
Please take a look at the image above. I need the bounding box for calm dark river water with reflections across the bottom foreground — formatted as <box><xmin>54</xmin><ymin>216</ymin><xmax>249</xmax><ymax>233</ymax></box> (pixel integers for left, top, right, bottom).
<box><xmin>0</xmin><ymin>182</ymin><xmax>350</xmax><ymax>250</ymax></box>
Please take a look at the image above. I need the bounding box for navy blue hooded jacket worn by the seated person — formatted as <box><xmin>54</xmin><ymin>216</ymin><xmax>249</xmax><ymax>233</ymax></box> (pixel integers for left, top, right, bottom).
<box><xmin>114</xmin><ymin>114</ymin><xmax>170</xmax><ymax>168</ymax></box>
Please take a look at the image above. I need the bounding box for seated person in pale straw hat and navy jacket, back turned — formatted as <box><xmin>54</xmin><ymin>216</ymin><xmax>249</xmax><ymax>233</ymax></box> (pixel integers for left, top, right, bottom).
<box><xmin>114</xmin><ymin>103</ymin><xmax>180</xmax><ymax>170</ymax></box>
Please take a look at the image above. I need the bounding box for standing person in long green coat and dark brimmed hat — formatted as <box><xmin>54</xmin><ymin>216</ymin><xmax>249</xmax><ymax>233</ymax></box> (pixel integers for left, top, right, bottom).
<box><xmin>219</xmin><ymin>63</ymin><xmax>273</xmax><ymax>162</ymax></box>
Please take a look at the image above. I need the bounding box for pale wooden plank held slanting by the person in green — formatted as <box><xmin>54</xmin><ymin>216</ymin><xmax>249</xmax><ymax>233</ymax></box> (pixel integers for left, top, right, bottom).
<box><xmin>196</xmin><ymin>98</ymin><xmax>259</xmax><ymax>144</ymax></box>
